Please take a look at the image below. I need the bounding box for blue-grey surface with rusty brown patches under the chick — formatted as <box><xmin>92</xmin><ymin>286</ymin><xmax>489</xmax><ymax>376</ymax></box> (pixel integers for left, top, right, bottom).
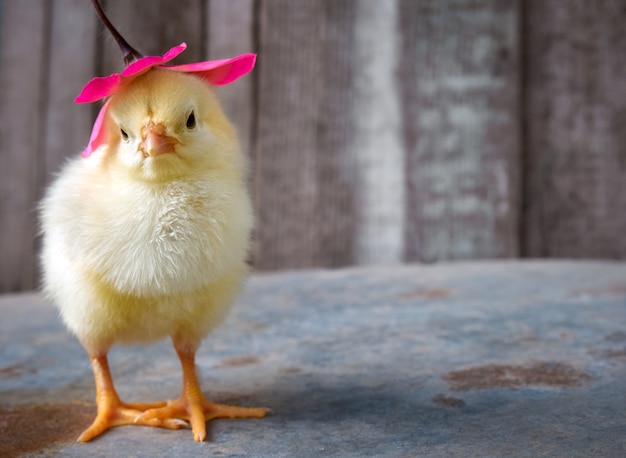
<box><xmin>0</xmin><ymin>261</ymin><xmax>626</xmax><ymax>457</ymax></box>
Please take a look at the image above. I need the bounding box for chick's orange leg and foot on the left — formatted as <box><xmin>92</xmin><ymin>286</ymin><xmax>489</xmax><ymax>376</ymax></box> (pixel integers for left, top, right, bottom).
<box><xmin>78</xmin><ymin>354</ymin><xmax>186</xmax><ymax>442</ymax></box>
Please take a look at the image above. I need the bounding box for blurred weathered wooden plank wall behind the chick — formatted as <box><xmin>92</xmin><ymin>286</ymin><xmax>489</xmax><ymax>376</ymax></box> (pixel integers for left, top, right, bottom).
<box><xmin>0</xmin><ymin>0</ymin><xmax>626</xmax><ymax>292</ymax></box>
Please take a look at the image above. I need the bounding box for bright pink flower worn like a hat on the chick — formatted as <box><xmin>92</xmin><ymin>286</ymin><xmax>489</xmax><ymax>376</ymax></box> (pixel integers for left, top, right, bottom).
<box><xmin>74</xmin><ymin>43</ymin><xmax>256</xmax><ymax>157</ymax></box>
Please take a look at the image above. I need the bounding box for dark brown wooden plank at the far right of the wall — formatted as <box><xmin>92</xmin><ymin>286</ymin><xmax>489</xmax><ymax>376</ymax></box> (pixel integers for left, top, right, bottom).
<box><xmin>524</xmin><ymin>0</ymin><xmax>626</xmax><ymax>259</ymax></box>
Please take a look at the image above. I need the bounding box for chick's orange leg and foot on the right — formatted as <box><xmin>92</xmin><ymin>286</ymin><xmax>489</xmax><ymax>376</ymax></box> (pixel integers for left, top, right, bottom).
<box><xmin>140</xmin><ymin>348</ymin><xmax>270</xmax><ymax>442</ymax></box>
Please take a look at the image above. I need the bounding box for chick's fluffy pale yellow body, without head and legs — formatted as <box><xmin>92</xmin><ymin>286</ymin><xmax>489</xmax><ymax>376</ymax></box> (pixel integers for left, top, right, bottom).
<box><xmin>44</xmin><ymin>162</ymin><xmax>251</xmax><ymax>350</ymax></box>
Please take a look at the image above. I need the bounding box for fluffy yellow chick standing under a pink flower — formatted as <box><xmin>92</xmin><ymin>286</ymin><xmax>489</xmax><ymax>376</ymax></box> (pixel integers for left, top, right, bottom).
<box><xmin>41</xmin><ymin>67</ymin><xmax>268</xmax><ymax>442</ymax></box>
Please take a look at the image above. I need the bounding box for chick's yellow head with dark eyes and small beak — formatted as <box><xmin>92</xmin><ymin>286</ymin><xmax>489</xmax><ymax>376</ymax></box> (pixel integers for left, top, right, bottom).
<box><xmin>104</xmin><ymin>68</ymin><xmax>243</xmax><ymax>182</ymax></box>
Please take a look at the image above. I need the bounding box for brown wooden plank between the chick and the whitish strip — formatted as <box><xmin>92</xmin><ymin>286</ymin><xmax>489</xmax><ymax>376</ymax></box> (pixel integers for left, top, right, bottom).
<box><xmin>255</xmin><ymin>1</ymin><xmax>355</xmax><ymax>269</ymax></box>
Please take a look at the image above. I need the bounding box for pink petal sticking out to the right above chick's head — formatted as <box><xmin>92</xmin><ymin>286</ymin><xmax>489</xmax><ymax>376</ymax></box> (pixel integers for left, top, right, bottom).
<box><xmin>163</xmin><ymin>54</ymin><xmax>256</xmax><ymax>85</ymax></box>
